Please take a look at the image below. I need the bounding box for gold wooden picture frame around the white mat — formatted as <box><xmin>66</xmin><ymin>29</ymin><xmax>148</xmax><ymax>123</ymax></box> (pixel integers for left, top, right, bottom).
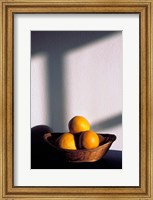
<box><xmin>0</xmin><ymin>0</ymin><xmax>153</xmax><ymax>200</ymax></box>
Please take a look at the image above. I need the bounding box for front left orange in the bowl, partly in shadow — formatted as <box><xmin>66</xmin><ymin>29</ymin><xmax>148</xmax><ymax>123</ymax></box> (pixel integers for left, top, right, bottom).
<box><xmin>58</xmin><ymin>133</ymin><xmax>76</xmax><ymax>150</ymax></box>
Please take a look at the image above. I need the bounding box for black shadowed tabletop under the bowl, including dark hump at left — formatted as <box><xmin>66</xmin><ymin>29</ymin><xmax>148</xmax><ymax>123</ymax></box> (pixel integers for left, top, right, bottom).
<box><xmin>31</xmin><ymin>125</ymin><xmax>122</xmax><ymax>169</ymax></box>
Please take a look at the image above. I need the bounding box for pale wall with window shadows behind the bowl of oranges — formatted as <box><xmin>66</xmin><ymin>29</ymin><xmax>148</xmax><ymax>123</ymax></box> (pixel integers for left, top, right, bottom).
<box><xmin>31</xmin><ymin>31</ymin><xmax>123</xmax><ymax>150</ymax></box>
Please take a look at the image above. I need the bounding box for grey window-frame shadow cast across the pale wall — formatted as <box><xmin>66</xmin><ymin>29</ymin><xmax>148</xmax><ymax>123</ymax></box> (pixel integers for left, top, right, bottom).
<box><xmin>31</xmin><ymin>31</ymin><xmax>121</xmax><ymax>131</ymax></box>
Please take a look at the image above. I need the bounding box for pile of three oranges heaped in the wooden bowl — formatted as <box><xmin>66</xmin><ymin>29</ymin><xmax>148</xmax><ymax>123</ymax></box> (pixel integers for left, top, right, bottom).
<box><xmin>58</xmin><ymin>116</ymin><xmax>99</xmax><ymax>150</ymax></box>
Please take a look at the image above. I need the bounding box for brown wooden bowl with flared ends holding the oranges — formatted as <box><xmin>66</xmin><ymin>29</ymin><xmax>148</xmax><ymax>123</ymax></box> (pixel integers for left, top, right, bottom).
<box><xmin>43</xmin><ymin>133</ymin><xmax>116</xmax><ymax>162</ymax></box>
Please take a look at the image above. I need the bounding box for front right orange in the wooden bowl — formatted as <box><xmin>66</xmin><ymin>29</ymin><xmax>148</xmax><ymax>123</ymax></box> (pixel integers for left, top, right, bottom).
<box><xmin>79</xmin><ymin>130</ymin><xmax>99</xmax><ymax>149</ymax></box>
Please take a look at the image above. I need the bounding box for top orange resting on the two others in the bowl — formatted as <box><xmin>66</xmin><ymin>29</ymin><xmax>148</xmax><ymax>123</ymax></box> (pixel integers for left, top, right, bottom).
<box><xmin>69</xmin><ymin>116</ymin><xmax>90</xmax><ymax>133</ymax></box>
